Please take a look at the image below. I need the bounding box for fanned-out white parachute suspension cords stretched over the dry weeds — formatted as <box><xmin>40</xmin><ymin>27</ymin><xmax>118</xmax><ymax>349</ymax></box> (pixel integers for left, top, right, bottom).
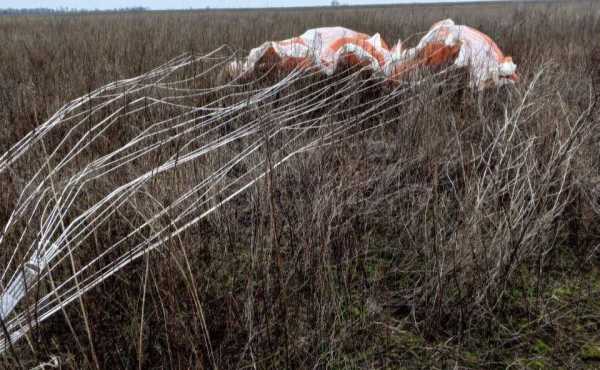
<box><xmin>0</xmin><ymin>47</ymin><xmax>458</xmax><ymax>351</ymax></box>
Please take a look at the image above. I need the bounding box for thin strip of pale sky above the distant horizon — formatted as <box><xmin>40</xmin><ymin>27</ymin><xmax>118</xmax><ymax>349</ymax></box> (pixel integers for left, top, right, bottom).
<box><xmin>0</xmin><ymin>0</ymin><xmax>482</xmax><ymax>9</ymax></box>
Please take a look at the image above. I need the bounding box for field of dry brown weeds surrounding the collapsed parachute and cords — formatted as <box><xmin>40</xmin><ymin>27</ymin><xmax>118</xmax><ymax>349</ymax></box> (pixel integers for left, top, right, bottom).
<box><xmin>0</xmin><ymin>1</ymin><xmax>600</xmax><ymax>369</ymax></box>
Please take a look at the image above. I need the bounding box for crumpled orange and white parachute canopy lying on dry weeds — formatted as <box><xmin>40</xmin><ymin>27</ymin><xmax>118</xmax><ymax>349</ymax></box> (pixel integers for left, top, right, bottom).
<box><xmin>229</xmin><ymin>19</ymin><xmax>517</xmax><ymax>89</ymax></box>
